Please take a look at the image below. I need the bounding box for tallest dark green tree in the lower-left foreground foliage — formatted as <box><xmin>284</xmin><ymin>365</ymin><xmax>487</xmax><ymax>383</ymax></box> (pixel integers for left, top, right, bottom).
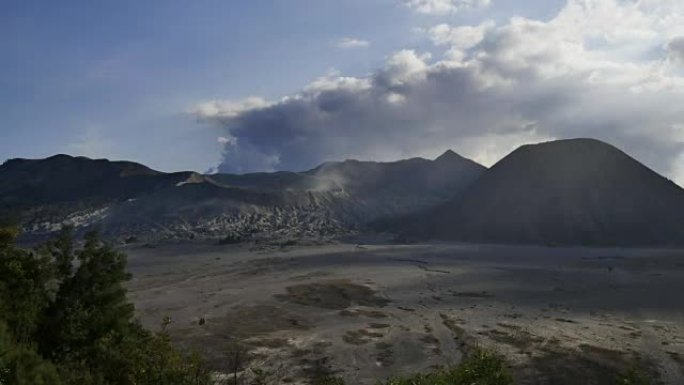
<box><xmin>41</xmin><ymin>230</ymin><xmax>133</xmax><ymax>381</ymax></box>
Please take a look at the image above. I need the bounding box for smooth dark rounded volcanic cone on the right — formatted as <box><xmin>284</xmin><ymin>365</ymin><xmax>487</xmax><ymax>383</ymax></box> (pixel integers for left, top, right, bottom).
<box><xmin>416</xmin><ymin>139</ymin><xmax>684</xmax><ymax>245</ymax></box>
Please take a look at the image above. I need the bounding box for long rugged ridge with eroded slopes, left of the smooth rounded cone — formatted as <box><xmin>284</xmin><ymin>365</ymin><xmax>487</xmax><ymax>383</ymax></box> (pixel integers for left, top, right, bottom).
<box><xmin>0</xmin><ymin>151</ymin><xmax>486</xmax><ymax>241</ymax></box>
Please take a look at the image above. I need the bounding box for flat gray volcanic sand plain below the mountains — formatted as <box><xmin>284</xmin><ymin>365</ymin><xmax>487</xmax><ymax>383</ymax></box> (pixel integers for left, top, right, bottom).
<box><xmin>126</xmin><ymin>244</ymin><xmax>684</xmax><ymax>384</ymax></box>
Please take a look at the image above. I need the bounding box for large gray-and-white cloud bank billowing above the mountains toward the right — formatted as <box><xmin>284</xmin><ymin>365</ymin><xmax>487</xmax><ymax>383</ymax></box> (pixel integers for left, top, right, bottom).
<box><xmin>194</xmin><ymin>0</ymin><xmax>684</xmax><ymax>183</ymax></box>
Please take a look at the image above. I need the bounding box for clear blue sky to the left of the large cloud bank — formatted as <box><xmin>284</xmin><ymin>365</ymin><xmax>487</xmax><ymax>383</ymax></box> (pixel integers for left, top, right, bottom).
<box><xmin>0</xmin><ymin>0</ymin><xmax>564</xmax><ymax>170</ymax></box>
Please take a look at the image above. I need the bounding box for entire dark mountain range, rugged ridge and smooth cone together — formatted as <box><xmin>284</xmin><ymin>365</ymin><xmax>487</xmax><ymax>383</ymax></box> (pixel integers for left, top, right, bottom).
<box><xmin>5</xmin><ymin>138</ymin><xmax>684</xmax><ymax>246</ymax></box>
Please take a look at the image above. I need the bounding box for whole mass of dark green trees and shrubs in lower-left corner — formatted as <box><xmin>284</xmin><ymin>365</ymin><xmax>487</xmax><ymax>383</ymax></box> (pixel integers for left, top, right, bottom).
<box><xmin>0</xmin><ymin>228</ymin><xmax>210</xmax><ymax>385</ymax></box>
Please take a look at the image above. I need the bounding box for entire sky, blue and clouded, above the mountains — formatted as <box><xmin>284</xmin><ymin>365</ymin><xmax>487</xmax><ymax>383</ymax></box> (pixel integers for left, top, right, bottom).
<box><xmin>0</xmin><ymin>0</ymin><xmax>684</xmax><ymax>182</ymax></box>
